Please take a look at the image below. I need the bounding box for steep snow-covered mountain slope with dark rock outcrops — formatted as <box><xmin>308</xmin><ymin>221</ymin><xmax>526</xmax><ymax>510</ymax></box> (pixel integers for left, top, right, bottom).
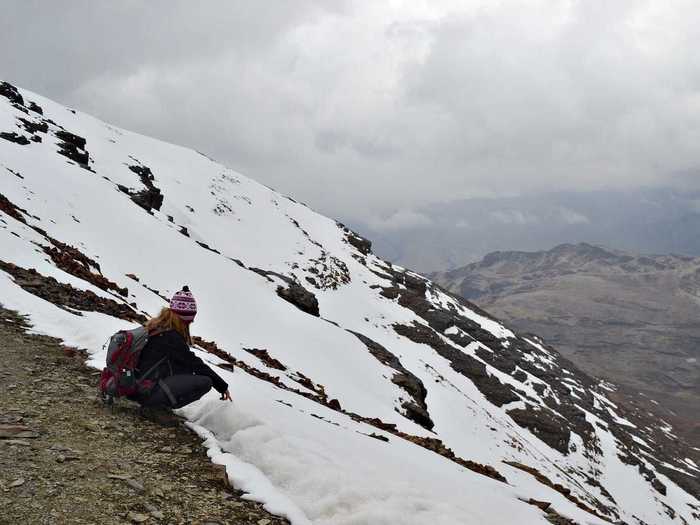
<box><xmin>0</xmin><ymin>79</ymin><xmax>700</xmax><ymax>525</ymax></box>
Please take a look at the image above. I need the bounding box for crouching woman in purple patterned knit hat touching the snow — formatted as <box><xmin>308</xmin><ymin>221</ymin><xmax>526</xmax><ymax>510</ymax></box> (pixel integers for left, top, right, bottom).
<box><xmin>134</xmin><ymin>286</ymin><xmax>231</xmax><ymax>409</ymax></box>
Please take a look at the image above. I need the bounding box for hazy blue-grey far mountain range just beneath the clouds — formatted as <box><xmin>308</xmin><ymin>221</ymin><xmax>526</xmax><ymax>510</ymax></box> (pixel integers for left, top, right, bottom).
<box><xmin>349</xmin><ymin>188</ymin><xmax>700</xmax><ymax>272</ymax></box>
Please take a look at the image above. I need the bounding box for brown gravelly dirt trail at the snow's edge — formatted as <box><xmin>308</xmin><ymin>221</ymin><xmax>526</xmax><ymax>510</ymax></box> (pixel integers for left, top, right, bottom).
<box><xmin>0</xmin><ymin>307</ymin><xmax>288</xmax><ymax>525</ymax></box>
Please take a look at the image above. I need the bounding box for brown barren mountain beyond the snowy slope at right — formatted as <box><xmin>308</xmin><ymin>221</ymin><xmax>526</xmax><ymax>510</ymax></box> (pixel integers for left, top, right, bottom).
<box><xmin>431</xmin><ymin>243</ymin><xmax>700</xmax><ymax>446</ymax></box>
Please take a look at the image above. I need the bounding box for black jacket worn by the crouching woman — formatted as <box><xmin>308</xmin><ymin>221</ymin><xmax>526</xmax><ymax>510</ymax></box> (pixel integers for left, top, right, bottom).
<box><xmin>137</xmin><ymin>330</ymin><xmax>228</xmax><ymax>394</ymax></box>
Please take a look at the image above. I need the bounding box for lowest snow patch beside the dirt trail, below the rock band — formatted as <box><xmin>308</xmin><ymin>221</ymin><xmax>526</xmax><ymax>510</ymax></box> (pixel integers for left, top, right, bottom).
<box><xmin>180</xmin><ymin>371</ymin><xmax>546</xmax><ymax>525</ymax></box>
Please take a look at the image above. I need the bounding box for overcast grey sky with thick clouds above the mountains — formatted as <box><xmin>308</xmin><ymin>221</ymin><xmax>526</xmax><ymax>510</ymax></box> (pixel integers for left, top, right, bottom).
<box><xmin>0</xmin><ymin>0</ymin><xmax>700</xmax><ymax>228</ymax></box>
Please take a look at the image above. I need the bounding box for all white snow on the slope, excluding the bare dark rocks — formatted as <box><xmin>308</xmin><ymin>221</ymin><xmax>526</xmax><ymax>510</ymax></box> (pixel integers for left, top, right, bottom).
<box><xmin>0</xmin><ymin>83</ymin><xmax>698</xmax><ymax>525</ymax></box>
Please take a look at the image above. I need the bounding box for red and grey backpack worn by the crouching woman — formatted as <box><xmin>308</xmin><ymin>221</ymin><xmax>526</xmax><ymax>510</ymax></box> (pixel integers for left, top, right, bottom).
<box><xmin>100</xmin><ymin>326</ymin><xmax>165</xmax><ymax>405</ymax></box>
